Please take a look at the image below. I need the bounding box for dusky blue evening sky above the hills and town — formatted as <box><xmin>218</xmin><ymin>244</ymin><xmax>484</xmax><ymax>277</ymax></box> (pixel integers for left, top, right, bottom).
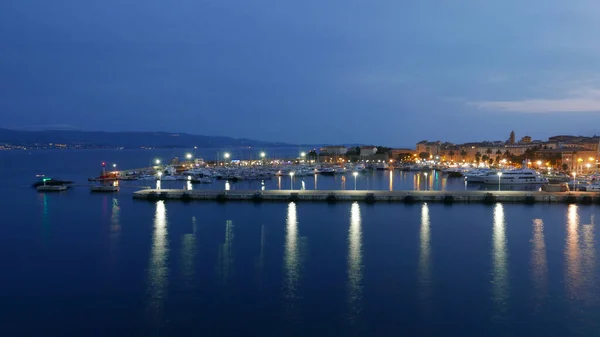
<box><xmin>0</xmin><ymin>0</ymin><xmax>600</xmax><ymax>146</ymax></box>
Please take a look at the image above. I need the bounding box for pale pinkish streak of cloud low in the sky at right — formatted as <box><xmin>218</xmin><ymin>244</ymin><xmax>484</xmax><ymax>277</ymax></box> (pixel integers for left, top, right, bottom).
<box><xmin>467</xmin><ymin>89</ymin><xmax>600</xmax><ymax>113</ymax></box>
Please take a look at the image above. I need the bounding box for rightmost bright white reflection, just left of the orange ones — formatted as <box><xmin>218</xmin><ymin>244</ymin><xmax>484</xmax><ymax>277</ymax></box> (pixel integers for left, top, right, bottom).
<box><xmin>492</xmin><ymin>203</ymin><xmax>509</xmax><ymax>315</ymax></box>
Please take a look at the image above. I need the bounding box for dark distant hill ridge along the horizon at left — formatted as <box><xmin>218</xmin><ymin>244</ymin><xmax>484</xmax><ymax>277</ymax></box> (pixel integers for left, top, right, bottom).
<box><xmin>0</xmin><ymin>128</ymin><xmax>297</xmax><ymax>148</ymax></box>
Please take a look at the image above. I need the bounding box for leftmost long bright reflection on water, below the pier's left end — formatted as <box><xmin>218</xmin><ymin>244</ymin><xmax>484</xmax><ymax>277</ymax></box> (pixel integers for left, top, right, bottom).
<box><xmin>147</xmin><ymin>200</ymin><xmax>169</xmax><ymax>324</ymax></box>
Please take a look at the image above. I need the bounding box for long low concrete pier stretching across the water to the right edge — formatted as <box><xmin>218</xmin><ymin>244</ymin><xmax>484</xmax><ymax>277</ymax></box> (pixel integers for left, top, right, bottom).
<box><xmin>133</xmin><ymin>189</ymin><xmax>600</xmax><ymax>204</ymax></box>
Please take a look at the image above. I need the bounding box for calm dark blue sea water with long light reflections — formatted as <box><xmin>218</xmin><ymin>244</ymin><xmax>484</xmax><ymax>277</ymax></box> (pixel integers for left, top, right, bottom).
<box><xmin>0</xmin><ymin>151</ymin><xmax>600</xmax><ymax>336</ymax></box>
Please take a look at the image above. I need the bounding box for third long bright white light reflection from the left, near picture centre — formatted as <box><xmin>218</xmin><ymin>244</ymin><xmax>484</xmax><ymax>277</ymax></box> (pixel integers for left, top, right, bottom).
<box><xmin>348</xmin><ymin>202</ymin><xmax>363</xmax><ymax>320</ymax></box>
